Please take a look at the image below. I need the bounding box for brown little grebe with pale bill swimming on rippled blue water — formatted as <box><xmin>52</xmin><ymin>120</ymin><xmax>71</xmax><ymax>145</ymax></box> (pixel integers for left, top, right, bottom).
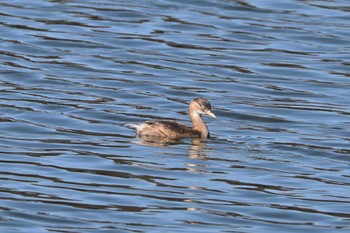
<box><xmin>125</xmin><ymin>98</ymin><xmax>216</xmax><ymax>139</ymax></box>
